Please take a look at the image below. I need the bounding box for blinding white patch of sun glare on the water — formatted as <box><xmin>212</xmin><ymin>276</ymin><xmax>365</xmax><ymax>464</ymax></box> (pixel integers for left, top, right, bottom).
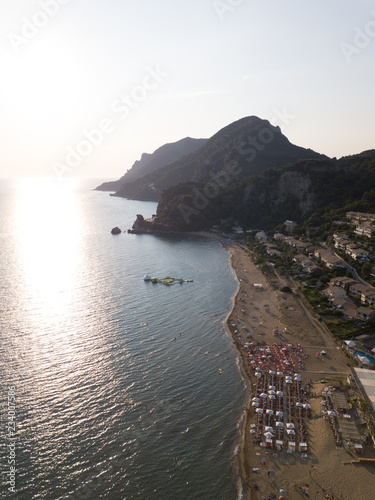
<box><xmin>15</xmin><ymin>178</ymin><xmax>82</xmax><ymax>307</ymax></box>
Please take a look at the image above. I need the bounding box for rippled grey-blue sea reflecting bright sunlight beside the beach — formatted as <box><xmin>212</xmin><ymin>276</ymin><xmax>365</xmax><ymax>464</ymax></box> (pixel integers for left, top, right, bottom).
<box><xmin>0</xmin><ymin>178</ymin><xmax>248</xmax><ymax>500</ymax></box>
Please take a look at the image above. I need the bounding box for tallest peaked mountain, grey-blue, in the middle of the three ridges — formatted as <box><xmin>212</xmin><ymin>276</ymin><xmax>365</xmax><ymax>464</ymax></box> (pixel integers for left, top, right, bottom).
<box><xmin>110</xmin><ymin>116</ymin><xmax>325</xmax><ymax>201</ymax></box>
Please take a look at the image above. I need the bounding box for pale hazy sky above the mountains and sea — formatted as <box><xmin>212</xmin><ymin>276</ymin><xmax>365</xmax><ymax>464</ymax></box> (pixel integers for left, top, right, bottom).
<box><xmin>0</xmin><ymin>0</ymin><xmax>375</xmax><ymax>178</ymax></box>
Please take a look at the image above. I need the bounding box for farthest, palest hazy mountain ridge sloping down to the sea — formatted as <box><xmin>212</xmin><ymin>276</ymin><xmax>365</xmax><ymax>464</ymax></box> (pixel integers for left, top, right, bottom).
<box><xmin>96</xmin><ymin>137</ymin><xmax>207</xmax><ymax>191</ymax></box>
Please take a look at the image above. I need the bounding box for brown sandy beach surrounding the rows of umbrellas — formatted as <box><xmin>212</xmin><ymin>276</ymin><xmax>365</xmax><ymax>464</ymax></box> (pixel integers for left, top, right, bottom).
<box><xmin>228</xmin><ymin>244</ymin><xmax>375</xmax><ymax>500</ymax></box>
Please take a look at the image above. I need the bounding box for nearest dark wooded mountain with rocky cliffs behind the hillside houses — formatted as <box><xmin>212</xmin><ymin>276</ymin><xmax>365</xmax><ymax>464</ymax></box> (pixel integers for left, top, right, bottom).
<box><xmin>153</xmin><ymin>150</ymin><xmax>375</xmax><ymax>231</ymax></box>
